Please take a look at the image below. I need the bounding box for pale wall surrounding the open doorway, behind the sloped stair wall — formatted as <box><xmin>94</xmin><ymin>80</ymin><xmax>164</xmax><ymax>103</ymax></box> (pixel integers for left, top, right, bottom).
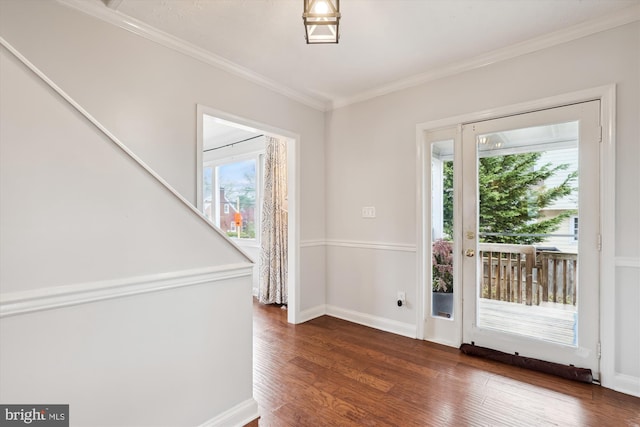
<box><xmin>0</xmin><ymin>0</ymin><xmax>325</xmax><ymax>310</ymax></box>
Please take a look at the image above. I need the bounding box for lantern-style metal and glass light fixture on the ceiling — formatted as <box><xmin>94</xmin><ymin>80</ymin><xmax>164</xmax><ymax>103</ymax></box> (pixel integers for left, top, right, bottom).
<box><xmin>302</xmin><ymin>0</ymin><xmax>340</xmax><ymax>44</ymax></box>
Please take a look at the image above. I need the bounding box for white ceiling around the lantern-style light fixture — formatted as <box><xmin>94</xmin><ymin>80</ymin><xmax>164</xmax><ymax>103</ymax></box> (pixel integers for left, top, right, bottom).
<box><xmin>86</xmin><ymin>0</ymin><xmax>640</xmax><ymax>108</ymax></box>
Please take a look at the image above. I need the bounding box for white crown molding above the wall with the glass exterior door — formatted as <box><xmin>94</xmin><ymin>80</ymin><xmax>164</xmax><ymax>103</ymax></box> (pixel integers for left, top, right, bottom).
<box><xmin>330</xmin><ymin>5</ymin><xmax>640</xmax><ymax>110</ymax></box>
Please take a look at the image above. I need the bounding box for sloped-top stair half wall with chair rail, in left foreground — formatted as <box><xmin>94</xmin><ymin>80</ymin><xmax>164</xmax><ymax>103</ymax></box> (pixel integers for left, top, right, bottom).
<box><xmin>0</xmin><ymin>34</ymin><xmax>257</xmax><ymax>426</ymax></box>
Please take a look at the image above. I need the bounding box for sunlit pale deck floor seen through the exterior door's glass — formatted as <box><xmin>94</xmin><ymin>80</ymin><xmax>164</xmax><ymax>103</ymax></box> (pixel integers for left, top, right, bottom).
<box><xmin>478</xmin><ymin>298</ymin><xmax>577</xmax><ymax>345</ymax></box>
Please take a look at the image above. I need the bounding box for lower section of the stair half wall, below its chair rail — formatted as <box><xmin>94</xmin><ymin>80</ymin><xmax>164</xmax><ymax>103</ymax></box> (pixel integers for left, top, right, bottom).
<box><xmin>0</xmin><ymin>276</ymin><xmax>257</xmax><ymax>427</ymax></box>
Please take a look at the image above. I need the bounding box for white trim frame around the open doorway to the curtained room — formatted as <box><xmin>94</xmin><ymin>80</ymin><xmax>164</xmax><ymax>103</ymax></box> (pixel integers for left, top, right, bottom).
<box><xmin>196</xmin><ymin>104</ymin><xmax>302</xmax><ymax>324</ymax></box>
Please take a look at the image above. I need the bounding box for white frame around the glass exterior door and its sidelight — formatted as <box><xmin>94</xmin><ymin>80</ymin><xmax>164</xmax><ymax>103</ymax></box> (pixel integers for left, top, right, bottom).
<box><xmin>416</xmin><ymin>84</ymin><xmax>616</xmax><ymax>386</ymax></box>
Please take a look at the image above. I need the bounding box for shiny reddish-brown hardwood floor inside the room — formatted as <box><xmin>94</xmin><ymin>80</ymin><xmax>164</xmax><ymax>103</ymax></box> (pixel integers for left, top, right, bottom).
<box><xmin>250</xmin><ymin>303</ymin><xmax>640</xmax><ymax>427</ymax></box>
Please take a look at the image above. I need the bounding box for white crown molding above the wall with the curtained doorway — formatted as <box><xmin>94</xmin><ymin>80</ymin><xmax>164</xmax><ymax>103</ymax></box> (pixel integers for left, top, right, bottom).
<box><xmin>57</xmin><ymin>0</ymin><xmax>329</xmax><ymax>111</ymax></box>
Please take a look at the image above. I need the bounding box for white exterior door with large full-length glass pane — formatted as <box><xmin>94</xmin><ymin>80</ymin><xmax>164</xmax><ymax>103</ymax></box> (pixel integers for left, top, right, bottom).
<box><xmin>460</xmin><ymin>101</ymin><xmax>600</xmax><ymax>379</ymax></box>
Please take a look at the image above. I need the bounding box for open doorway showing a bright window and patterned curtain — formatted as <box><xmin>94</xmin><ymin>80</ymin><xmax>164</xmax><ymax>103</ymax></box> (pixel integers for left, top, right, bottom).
<box><xmin>196</xmin><ymin>105</ymin><xmax>299</xmax><ymax>323</ymax></box>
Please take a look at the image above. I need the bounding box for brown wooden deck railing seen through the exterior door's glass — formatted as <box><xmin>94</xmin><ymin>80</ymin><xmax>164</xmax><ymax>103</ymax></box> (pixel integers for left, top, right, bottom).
<box><xmin>479</xmin><ymin>243</ymin><xmax>578</xmax><ymax>305</ymax></box>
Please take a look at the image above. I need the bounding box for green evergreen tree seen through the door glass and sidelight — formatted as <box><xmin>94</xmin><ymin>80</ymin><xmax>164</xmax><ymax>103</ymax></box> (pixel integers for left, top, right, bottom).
<box><xmin>443</xmin><ymin>153</ymin><xmax>578</xmax><ymax>244</ymax></box>
